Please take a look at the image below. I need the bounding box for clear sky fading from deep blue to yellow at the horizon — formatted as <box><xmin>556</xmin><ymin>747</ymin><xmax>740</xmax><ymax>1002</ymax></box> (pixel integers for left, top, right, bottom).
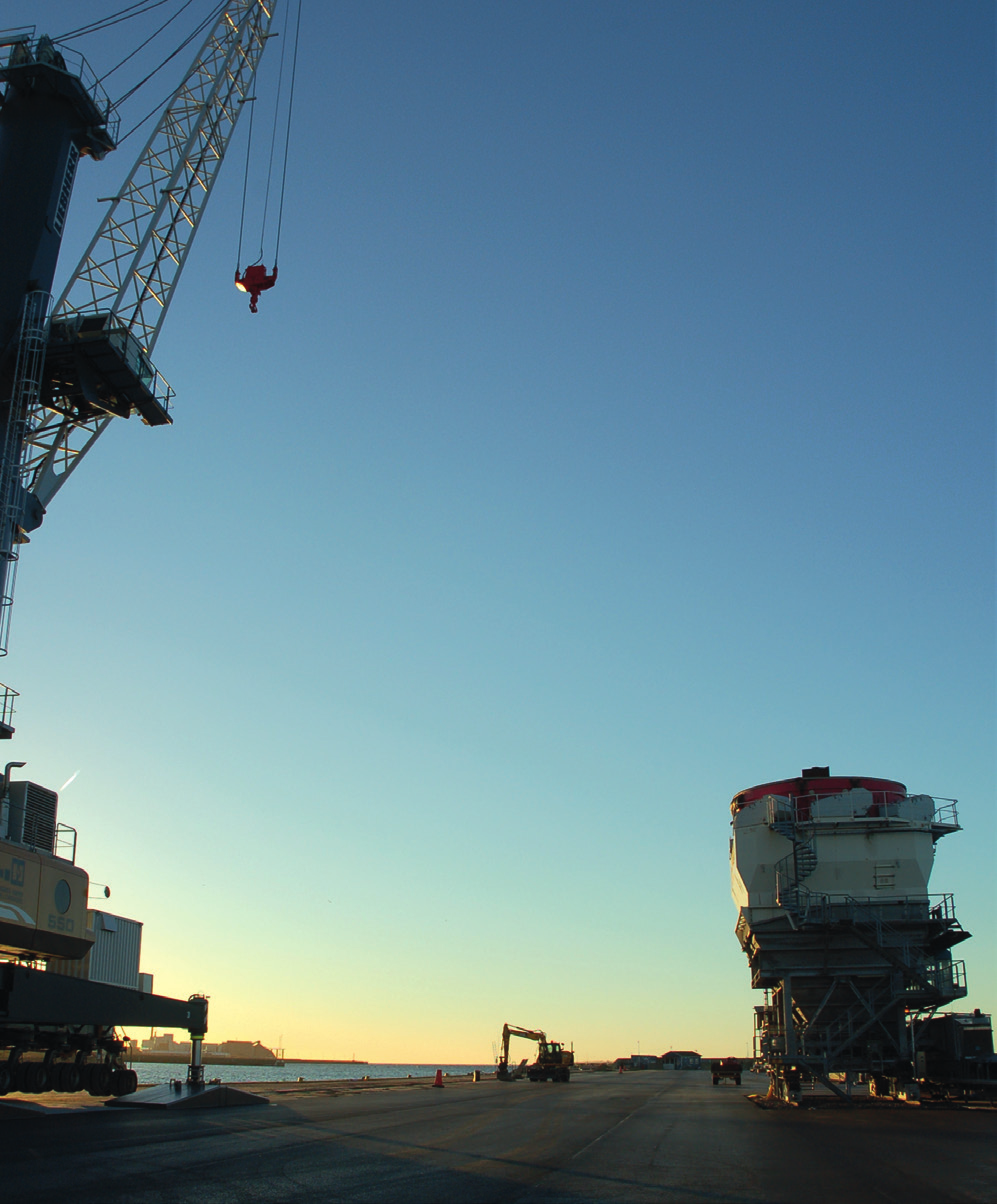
<box><xmin>2</xmin><ymin>0</ymin><xmax>997</xmax><ymax>1062</ymax></box>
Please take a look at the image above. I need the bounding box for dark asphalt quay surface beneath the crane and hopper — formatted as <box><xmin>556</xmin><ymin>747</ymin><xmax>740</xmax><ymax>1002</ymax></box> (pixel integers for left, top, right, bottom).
<box><xmin>0</xmin><ymin>1070</ymin><xmax>997</xmax><ymax>1204</ymax></box>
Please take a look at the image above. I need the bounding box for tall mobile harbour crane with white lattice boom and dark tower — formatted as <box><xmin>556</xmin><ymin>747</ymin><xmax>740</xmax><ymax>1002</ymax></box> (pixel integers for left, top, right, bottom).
<box><xmin>0</xmin><ymin>0</ymin><xmax>273</xmax><ymax>1096</ymax></box>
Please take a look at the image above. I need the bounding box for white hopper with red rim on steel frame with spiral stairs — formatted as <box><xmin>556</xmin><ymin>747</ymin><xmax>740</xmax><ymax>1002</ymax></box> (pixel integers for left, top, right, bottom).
<box><xmin>730</xmin><ymin>766</ymin><xmax>969</xmax><ymax>1100</ymax></box>
